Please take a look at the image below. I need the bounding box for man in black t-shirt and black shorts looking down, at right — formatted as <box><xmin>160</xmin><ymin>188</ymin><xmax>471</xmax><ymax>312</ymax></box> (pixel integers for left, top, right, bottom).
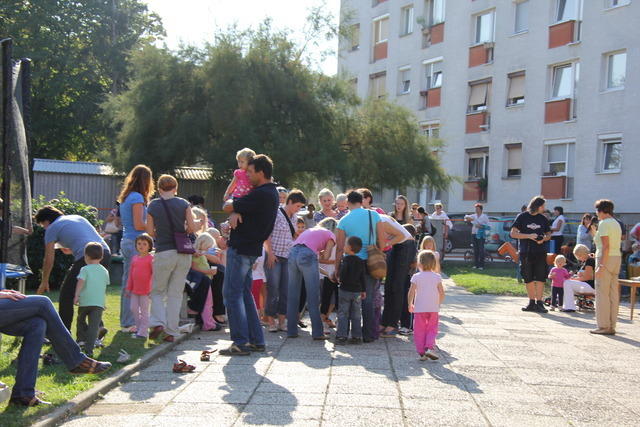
<box><xmin>511</xmin><ymin>196</ymin><xmax>551</xmax><ymax>313</ymax></box>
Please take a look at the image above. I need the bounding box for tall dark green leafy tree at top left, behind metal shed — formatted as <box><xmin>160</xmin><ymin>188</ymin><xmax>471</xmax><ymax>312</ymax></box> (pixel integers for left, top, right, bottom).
<box><xmin>0</xmin><ymin>0</ymin><xmax>163</xmax><ymax>159</ymax></box>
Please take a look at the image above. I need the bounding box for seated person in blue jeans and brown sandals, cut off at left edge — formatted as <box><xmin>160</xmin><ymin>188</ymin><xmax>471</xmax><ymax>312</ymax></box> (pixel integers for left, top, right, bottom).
<box><xmin>0</xmin><ymin>289</ymin><xmax>111</xmax><ymax>406</ymax></box>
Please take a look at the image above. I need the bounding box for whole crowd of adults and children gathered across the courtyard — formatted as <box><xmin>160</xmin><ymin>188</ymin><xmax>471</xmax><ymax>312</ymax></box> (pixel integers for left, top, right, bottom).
<box><xmin>0</xmin><ymin>149</ymin><xmax>640</xmax><ymax>405</ymax></box>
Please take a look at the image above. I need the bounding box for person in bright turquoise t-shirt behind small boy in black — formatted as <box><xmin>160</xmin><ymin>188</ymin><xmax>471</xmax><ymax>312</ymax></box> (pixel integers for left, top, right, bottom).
<box><xmin>335</xmin><ymin>191</ymin><xmax>384</xmax><ymax>342</ymax></box>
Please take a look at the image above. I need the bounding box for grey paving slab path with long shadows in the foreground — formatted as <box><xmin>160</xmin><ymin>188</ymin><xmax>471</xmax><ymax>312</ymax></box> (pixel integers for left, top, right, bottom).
<box><xmin>61</xmin><ymin>287</ymin><xmax>640</xmax><ymax>427</ymax></box>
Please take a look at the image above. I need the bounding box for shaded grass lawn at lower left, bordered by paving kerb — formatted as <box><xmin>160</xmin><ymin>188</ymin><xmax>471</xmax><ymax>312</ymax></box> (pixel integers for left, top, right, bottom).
<box><xmin>0</xmin><ymin>286</ymin><xmax>156</xmax><ymax>426</ymax></box>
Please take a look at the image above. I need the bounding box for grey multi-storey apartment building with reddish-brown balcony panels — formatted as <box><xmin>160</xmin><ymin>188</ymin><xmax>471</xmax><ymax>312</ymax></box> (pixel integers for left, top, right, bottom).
<box><xmin>339</xmin><ymin>0</ymin><xmax>640</xmax><ymax>216</ymax></box>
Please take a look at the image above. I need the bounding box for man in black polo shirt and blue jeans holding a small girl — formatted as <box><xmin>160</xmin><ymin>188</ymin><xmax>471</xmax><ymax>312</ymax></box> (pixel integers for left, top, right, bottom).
<box><xmin>220</xmin><ymin>154</ymin><xmax>279</xmax><ymax>356</ymax></box>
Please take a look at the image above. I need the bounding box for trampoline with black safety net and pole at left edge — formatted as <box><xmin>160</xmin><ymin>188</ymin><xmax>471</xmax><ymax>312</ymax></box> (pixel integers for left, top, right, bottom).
<box><xmin>0</xmin><ymin>38</ymin><xmax>33</xmax><ymax>291</ymax></box>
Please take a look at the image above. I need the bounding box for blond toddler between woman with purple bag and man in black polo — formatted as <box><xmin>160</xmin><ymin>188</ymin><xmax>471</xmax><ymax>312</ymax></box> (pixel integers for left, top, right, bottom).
<box><xmin>189</xmin><ymin>233</ymin><xmax>221</xmax><ymax>331</ymax></box>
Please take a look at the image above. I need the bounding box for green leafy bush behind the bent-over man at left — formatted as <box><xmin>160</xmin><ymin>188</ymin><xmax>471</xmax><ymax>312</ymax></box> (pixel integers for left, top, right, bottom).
<box><xmin>27</xmin><ymin>192</ymin><xmax>101</xmax><ymax>289</ymax></box>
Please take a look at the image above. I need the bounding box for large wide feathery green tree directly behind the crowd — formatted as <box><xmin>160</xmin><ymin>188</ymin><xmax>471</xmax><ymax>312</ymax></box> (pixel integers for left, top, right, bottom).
<box><xmin>105</xmin><ymin>14</ymin><xmax>450</xmax><ymax>188</ymax></box>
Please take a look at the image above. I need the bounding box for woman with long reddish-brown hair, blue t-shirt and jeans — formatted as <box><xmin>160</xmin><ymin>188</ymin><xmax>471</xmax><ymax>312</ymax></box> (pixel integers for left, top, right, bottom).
<box><xmin>118</xmin><ymin>165</ymin><xmax>155</xmax><ymax>332</ymax></box>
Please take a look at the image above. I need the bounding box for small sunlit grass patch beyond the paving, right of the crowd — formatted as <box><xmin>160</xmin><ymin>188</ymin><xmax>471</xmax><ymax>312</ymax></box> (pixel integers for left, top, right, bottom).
<box><xmin>442</xmin><ymin>260</ymin><xmax>544</xmax><ymax>296</ymax></box>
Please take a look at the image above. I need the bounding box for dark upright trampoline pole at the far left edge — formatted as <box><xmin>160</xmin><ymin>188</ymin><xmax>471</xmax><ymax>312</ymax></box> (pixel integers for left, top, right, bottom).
<box><xmin>0</xmin><ymin>39</ymin><xmax>13</xmax><ymax>268</ymax></box>
